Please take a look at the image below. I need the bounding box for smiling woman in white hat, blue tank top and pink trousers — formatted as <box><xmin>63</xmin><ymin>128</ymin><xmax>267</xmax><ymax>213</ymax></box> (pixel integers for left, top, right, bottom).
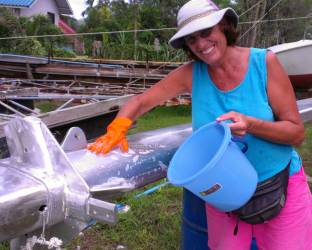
<box><xmin>89</xmin><ymin>0</ymin><xmax>312</xmax><ymax>250</ymax></box>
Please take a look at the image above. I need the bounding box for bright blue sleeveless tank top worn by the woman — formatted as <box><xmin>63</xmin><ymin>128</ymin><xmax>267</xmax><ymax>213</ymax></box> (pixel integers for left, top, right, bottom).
<box><xmin>192</xmin><ymin>48</ymin><xmax>301</xmax><ymax>181</ymax></box>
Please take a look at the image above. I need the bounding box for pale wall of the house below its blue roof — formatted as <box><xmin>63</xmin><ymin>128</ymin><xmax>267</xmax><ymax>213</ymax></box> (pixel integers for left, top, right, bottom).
<box><xmin>20</xmin><ymin>0</ymin><xmax>60</xmax><ymax>25</ymax></box>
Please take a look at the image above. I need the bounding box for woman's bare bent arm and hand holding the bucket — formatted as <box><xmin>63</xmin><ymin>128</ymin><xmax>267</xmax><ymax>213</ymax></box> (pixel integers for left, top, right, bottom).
<box><xmin>218</xmin><ymin>52</ymin><xmax>304</xmax><ymax>146</ymax></box>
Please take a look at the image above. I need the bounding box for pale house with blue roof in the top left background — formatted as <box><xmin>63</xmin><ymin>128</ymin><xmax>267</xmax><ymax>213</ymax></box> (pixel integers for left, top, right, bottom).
<box><xmin>0</xmin><ymin>0</ymin><xmax>73</xmax><ymax>26</ymax></box>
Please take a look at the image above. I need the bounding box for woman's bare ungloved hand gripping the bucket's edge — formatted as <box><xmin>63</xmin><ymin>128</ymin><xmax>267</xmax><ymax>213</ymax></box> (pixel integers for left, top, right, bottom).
<box><xmin>216</xmin><ymin>111</ymin><xmax>251</xmax><ymax>136</ymax></box>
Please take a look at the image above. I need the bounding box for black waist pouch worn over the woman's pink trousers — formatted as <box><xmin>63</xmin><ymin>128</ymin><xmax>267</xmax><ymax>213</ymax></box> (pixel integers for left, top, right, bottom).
<box><xmin>232</xmin><ymin>163</ymin><xmax>290</xmax><ymax>224</ymax></box>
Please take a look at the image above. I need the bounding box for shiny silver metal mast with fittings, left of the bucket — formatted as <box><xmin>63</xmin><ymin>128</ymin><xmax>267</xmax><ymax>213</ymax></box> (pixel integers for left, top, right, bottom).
<box><xmin>0</xmin><ymin>116</ymin><xmax>191</xmax><ymax>249</ymax></box>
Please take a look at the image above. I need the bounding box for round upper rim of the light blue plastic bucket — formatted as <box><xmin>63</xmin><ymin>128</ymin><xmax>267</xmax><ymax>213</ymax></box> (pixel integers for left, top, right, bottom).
<box><xmin>167</xmin><ymin>121</ymin><xmax>231</xmax><ymax>186</ymax></box>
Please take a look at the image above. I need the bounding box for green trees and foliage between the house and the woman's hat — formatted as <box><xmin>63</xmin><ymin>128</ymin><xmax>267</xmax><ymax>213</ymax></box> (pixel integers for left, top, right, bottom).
<box><xmin>79</xmin><ymin>0</ymin><xmax>190</xmax><ymax>61</ymax></box>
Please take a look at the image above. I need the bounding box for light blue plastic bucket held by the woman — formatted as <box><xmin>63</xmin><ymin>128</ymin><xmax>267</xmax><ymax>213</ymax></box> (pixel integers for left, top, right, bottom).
<box><xmin>167</xmin><ymin>122</ymin><xmax>258</xmax><ymax>212</ymax></box>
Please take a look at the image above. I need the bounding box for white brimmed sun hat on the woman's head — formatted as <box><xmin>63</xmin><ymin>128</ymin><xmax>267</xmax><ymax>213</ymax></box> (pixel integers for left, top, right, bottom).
<box><xmin>169</xmin><ymin>0</ymin><xmax>238</xmax><ymax>49</ymax></box>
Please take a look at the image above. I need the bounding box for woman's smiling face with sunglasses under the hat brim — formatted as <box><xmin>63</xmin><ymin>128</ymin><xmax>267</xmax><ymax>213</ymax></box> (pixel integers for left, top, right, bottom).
<box><xmin>184</xmin><ymin>24</ymin><xmax>227</xmax><ymax>65</ymax></box>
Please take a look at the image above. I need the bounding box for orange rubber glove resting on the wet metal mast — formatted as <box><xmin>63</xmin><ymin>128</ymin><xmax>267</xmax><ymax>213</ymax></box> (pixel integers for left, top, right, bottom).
<box><xmin>88</xmin><ymin>117</ymin><xmax>132</xmax><ymax>154</ymax></box>
